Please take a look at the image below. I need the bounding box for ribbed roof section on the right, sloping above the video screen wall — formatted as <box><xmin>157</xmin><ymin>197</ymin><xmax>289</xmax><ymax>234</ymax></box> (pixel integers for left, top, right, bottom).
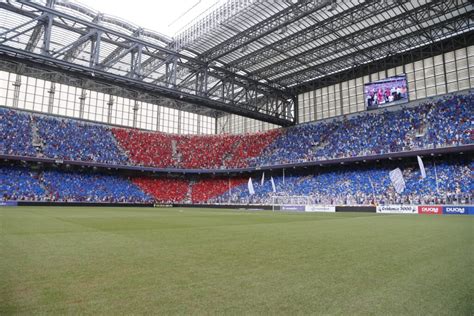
<box><xmin>178</xmin><ymin>0</ymin><xmax>473</xmax><ymax>88</ymax></box>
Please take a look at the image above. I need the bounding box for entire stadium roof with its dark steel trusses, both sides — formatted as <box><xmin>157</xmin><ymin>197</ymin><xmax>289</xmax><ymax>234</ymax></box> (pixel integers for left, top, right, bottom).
<box><xmin>0</xmin><ymin>0</ymin><xmax>473</xmax><ymax>125</ymax></box>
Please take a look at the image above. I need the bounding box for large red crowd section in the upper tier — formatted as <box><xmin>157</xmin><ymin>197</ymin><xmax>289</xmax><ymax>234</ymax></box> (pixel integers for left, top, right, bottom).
<box><xmin>113</xmin><ymin>128</ymin><xmax>281</xmax><ymax>169</ymax></box>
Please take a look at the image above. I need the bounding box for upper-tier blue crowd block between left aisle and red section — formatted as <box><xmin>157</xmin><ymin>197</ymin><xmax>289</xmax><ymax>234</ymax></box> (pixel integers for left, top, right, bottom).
<box><xmin>33</xmin><ymin>116</ymin><xmax>128</xmax><ymax>165</ymax></box>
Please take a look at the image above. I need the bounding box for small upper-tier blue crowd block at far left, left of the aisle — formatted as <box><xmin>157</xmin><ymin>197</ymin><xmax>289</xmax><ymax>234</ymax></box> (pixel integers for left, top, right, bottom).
<box><xmin>0</xmin><ymin>108</ymin><xmax>36</xmax><ymax>156</ymax></box>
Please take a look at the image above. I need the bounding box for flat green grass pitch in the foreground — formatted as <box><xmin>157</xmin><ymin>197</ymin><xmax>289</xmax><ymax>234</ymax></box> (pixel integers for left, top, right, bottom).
<box><xmin>0</xmin><ymin>207</ymin><xmax>474</xmax><ymax>315</ymax></box>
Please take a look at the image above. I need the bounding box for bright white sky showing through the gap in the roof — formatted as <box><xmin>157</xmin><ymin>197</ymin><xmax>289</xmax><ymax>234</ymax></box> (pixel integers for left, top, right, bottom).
<box><xmin>70</xmin><ymin>0</ymin><xmax>225</xmax><ymax>37</ymax></box>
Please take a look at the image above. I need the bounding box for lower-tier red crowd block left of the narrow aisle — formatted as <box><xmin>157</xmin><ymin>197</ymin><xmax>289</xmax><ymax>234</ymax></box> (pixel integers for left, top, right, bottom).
<box><xmin>133</xmin><ymin>178</ymin><xmax>189</xmax><ymax>203</ymax></box>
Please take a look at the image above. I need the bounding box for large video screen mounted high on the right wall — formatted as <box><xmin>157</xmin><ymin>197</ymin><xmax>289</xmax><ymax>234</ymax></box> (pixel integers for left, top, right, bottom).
<box><xmin>364</xmin><ymin>74</ymin><xmax>408</xmax><ymax>110</ymax></box>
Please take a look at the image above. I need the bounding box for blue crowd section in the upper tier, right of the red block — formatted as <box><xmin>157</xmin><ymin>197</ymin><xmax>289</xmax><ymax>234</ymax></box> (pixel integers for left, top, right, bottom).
<box><xmin>252</xmin><ymin>93</ymin><xmax>474</xmax><ymax>166</ymax></box>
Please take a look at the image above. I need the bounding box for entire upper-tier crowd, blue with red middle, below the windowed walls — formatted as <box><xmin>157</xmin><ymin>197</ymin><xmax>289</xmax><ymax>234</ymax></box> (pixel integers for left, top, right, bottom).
<box><xmin>0</xmin><ymin>93</ymin><xmax>474</xmax><ymax>169</ymax></box>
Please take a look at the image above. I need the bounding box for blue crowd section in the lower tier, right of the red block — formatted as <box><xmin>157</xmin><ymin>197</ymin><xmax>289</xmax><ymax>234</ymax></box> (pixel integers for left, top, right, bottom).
<box><xmin>216</xmin><ymin>158</ymin><xmax>474</xmax><ymax>205</ymax></box>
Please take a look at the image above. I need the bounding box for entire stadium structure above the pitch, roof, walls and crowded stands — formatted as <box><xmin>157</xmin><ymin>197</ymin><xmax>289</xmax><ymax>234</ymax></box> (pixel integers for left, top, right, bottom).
<box><xmin>0</xmin><ymin>0</ymin><xmax>474</xmax><ymax>209</ymax></box>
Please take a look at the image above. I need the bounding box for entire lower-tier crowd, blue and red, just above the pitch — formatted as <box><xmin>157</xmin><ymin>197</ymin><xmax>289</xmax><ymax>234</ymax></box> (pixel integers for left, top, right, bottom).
<box><xmin>0</xmin><ymin>156</ymin><xmax>474</xmax><ymax>205</ymax></box>
